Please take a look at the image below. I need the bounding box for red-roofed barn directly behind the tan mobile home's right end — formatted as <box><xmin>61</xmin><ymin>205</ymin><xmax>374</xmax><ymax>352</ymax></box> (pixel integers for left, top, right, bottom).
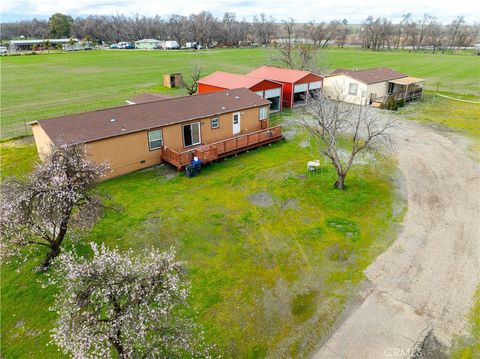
<box><xmin>198</xmin><ymin>71</ymin><xmax>283</xmax><ymax>112</ymax></box>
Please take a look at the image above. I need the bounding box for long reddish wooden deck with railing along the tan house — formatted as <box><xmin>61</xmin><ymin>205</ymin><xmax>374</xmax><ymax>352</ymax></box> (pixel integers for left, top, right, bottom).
<box><xmin>162</xmin><ymin>126</ymin><xmax>283</xmax><ymax>170</ymax></box>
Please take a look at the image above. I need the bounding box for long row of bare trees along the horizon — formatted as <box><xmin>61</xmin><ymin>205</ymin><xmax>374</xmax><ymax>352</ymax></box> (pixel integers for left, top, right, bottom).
<box><xmin>1</xmin><ymin>11</ymin><xmax>480</xmax><ymax>52</ymax></box>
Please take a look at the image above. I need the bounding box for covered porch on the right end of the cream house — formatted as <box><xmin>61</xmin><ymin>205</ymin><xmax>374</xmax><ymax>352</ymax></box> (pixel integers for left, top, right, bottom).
<box><xmin>373</xmin><ymin>76</ymin><xmax>425</xmax><ymax>104</ymax></box>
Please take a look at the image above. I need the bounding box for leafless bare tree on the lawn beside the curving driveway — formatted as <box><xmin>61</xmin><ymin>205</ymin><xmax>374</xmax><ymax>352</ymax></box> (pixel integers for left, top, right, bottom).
<box><xmin>301</xmin><ymin>94</ymin><xmax>394</xmax><ymax>190</ymax></box>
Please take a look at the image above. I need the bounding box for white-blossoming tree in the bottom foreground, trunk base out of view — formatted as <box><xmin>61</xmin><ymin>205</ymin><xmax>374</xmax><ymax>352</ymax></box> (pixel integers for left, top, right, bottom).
<box><xmin>49</xmin><ymin>244</ymin><xmax>209</xmax><ymax>359</ymax></box>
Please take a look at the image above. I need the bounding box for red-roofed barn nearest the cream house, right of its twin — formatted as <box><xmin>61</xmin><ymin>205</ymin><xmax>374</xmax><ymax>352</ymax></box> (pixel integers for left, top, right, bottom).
<box><xmin>247</xmin><ymin>66</ymin><xmax>323</xmax><ymax>107</ymax></box>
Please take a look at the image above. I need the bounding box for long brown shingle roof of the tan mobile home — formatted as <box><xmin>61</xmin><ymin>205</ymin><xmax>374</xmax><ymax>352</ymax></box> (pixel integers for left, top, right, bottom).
<box><xmin>38</xmin><ymin>88</ymin><xmax>270</xmax><ymax>144</ymax></box>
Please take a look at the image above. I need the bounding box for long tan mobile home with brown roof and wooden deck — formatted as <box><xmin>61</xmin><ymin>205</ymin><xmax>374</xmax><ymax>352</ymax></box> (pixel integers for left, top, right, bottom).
<box><xmin>31</xmin><ymin>88</ymin><xmax>282</xmax><ymax>177</ymax></box>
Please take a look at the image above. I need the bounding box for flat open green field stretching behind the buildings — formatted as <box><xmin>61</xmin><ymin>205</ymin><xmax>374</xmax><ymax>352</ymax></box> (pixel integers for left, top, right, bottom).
<box><xmin>0</xmin><ymin>48</ymin><xmax>480</xmax><ymax>138</ymax></box>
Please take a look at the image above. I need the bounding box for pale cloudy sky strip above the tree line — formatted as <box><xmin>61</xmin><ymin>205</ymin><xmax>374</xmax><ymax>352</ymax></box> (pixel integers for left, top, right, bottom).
<box><xmin>0</xmin><ymin>0</ymin><xmax>480</xmax><ymax>23</ymax></box>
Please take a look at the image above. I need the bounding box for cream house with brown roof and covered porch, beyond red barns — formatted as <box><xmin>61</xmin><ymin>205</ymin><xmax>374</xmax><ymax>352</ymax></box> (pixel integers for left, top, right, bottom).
<box><xmin>323</xmin><ymin>67</ymin><xmax>425</xmax><ymax>106</ymax></box>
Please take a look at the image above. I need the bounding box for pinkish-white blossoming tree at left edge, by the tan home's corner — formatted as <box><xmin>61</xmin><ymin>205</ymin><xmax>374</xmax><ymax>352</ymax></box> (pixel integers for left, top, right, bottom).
<box><xmin>0</xmin><ymin>144</ymin><xmax>108</xmax><ymax>268</ymax></box>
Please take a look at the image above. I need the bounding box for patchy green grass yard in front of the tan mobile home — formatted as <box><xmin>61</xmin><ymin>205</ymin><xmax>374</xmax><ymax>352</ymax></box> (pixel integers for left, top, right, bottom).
<box><xmin>1</xmin><ymin>120</ymin><xmax>403</xmax><ymax>358</ymax></box>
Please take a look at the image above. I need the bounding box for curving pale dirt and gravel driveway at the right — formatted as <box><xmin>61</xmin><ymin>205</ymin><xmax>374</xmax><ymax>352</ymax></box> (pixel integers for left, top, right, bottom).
<box><xmin>314</xmin><ymin>121</ymin><xmax>480</xmax><ymax>359</ymax></box>
